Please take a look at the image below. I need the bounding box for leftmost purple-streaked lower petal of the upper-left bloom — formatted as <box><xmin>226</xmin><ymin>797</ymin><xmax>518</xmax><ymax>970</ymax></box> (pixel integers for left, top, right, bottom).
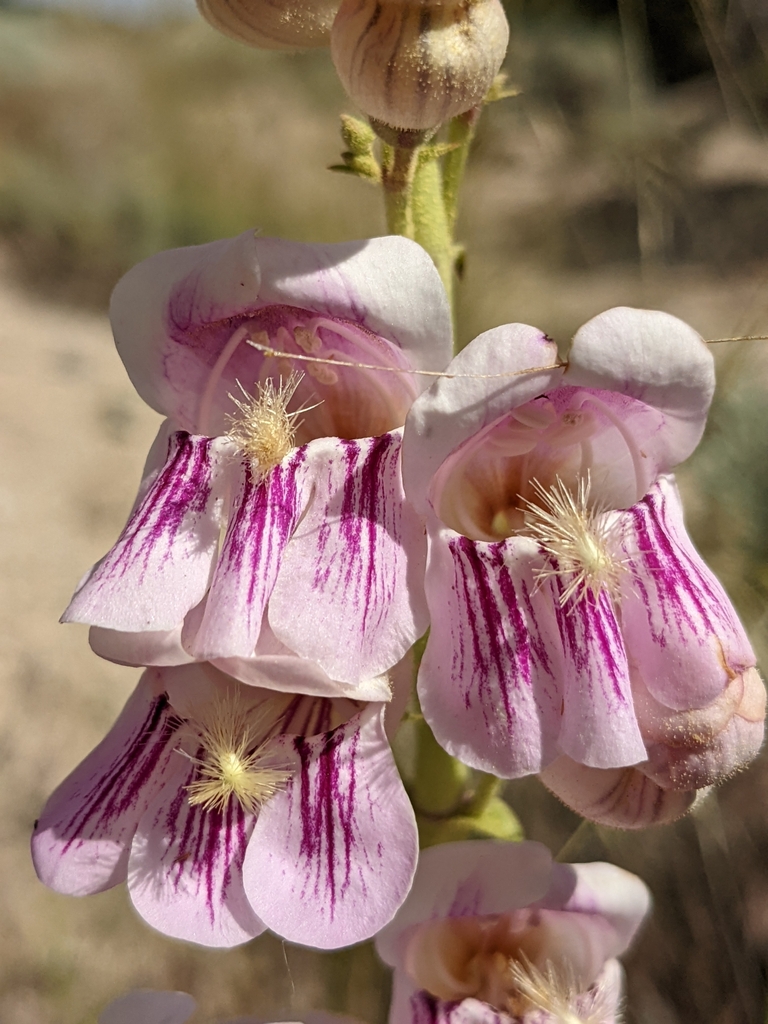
<box><xmin>61</xmin><ymin>431</ymin><xmax>225</xmax><ymax>632</ymax></box>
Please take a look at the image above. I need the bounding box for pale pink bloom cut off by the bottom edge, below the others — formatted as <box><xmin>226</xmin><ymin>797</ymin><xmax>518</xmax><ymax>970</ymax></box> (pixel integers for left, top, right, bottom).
<box><xmin>376</xmin><ymin>842</ymin><xmax>649</xmax><ymax>1024</ymax></box>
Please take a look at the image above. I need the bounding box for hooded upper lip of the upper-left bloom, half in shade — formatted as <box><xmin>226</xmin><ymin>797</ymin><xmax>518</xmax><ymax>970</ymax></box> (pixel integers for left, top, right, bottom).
<box><xmin>111</xmin><ymin>231</ymin><xmax>452</xmax><ymax>439</ymax></box>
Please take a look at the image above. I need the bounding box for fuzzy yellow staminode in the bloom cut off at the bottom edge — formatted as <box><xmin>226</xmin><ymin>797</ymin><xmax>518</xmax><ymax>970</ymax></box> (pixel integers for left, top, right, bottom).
<box><xmin>509</xmin><ymin>959</ymin><xmax>617</xmax><ymax>1024</ymax></box>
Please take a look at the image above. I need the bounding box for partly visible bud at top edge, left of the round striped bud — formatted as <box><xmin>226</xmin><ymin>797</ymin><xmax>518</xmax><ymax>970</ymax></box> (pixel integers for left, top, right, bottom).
<box><xmin>198</xmin><ymin>0</ymin><xmax>338</xmax><ymax>50</ymax></box>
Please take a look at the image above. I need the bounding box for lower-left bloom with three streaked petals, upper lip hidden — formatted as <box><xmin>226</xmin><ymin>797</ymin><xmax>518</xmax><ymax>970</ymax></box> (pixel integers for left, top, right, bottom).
<box><xmin>32</xmin><ymin>658</ymin><xmax>418</xmax><ymax>948</ymax></box>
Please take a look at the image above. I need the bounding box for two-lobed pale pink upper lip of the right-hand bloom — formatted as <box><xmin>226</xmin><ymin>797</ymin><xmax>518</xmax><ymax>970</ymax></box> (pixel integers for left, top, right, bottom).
<box><xmin>403</xmin><ymin>308</ymin><xmax>714</xmax><ymax>520</ymax></box>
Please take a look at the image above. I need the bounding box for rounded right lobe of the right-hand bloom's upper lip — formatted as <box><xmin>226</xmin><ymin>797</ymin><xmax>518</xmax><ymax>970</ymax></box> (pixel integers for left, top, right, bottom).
<box><xmin>563</xmin><ymin>306</ymin><xmax>715</xmax><ymax>472</ymax></box>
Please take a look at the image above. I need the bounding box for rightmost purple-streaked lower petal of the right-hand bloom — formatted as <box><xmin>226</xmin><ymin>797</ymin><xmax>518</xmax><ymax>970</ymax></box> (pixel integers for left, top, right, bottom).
<box><xmin>622</xmin><ymin>476</ymin><xmax>755</xmax><ymax>710</ymax></box>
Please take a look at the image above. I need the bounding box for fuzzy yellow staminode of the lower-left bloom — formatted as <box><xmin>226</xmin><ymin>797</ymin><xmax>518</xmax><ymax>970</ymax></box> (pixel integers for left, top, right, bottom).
<box><xmin>186</xmin><ymin>696</ymin><xmax>291</xmax><ymax>814</ymax></box>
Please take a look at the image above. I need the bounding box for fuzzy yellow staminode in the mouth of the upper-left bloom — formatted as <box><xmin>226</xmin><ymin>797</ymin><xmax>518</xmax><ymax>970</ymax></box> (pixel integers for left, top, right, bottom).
<box><xmin>227</xmin><ymin>373</ymin><xmax>307</xmax><ymax>477</ymax></box>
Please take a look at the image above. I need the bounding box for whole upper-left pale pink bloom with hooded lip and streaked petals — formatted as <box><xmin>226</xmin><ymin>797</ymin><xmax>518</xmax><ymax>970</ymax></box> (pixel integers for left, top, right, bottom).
<box><xmin>63</xmin><ymin>231</ymin><xmax>451</xmax><ymax>684</ymax></box>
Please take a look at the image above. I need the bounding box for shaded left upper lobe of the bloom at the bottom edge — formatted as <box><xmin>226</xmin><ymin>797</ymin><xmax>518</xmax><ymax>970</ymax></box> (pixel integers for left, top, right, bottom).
<box><xmin>376</xmin><ymin>840</ymin><xmax>552</xmax><ymax>968</ymax></box>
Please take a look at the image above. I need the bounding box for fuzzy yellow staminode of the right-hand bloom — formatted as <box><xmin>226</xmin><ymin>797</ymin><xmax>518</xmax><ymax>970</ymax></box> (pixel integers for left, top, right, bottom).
<box><xmin>523</xmin><ymin>475</ymin><xmax>627</xmax><ymax>607</ymax></box>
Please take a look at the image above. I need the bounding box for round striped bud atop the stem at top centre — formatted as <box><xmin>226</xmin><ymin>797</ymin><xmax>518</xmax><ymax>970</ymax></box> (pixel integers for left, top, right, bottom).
<box><xmin>331</xmin><ymin>0</ymin><xmax>509</xmax><ymax>129</ymax></box>
